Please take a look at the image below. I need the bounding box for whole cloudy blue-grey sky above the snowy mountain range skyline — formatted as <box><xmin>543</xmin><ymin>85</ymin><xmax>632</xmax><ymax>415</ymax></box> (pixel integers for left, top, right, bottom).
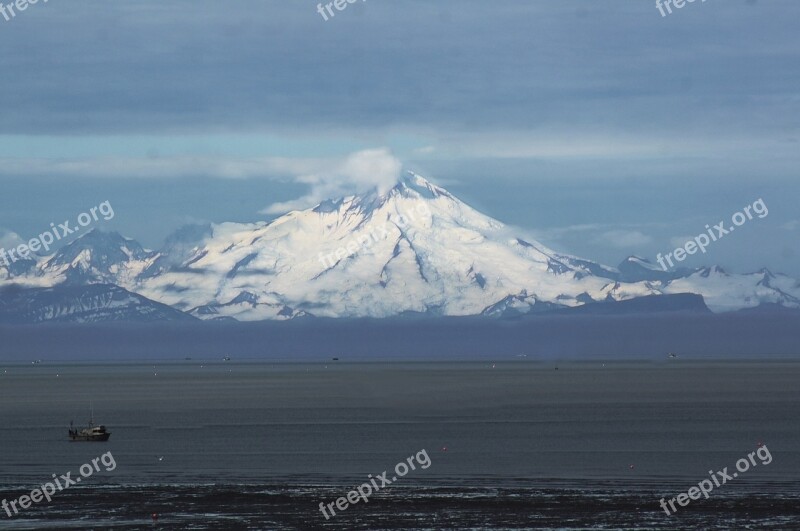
<box><xmin>0</xmin><ymin>0</ymin><xmax>800</xmax><ymax>278</ymax></box>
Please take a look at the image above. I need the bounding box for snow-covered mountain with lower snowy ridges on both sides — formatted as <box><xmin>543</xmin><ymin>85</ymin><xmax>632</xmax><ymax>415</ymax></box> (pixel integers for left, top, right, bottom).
<box><xmin>0</xmin><ymin>174</ymin><xmax>800</xmax><ymax>320</ymax></box>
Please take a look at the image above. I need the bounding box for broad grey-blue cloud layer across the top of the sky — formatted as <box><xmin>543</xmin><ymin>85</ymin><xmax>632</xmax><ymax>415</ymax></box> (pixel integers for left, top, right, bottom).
<box><xmin>0</xmin><ymin>0</ymin><xmax>800</xmax><ymax>154</ymax></box>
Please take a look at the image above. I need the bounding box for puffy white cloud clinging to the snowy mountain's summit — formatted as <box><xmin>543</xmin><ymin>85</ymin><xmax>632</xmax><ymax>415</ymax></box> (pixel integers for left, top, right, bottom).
<box><xmin>260</xmin><ymin>148</ymin><xmax>402</xmax><ymax>214</ymax></box>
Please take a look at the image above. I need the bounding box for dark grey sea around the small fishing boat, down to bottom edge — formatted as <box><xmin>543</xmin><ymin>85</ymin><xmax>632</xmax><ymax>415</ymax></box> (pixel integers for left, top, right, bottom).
<box><xmin>0</xmin><ymin>359</ymin><xmax>800</xmax><ymax>529</ymax></box>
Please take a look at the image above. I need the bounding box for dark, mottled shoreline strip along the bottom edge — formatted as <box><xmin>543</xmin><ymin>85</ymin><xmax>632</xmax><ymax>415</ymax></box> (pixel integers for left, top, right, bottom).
<box><xmin>0</xmin><ymin>485</ymin><xmax>800</xmax><ymax>530</ymax></box>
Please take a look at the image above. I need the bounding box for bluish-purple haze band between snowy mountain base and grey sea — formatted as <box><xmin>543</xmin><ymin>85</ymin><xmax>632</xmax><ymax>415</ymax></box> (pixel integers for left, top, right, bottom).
<box><xmin>0</xmin><ymin>314</ymin><xmax>800</xmax><ymax>368</ymax></box>
